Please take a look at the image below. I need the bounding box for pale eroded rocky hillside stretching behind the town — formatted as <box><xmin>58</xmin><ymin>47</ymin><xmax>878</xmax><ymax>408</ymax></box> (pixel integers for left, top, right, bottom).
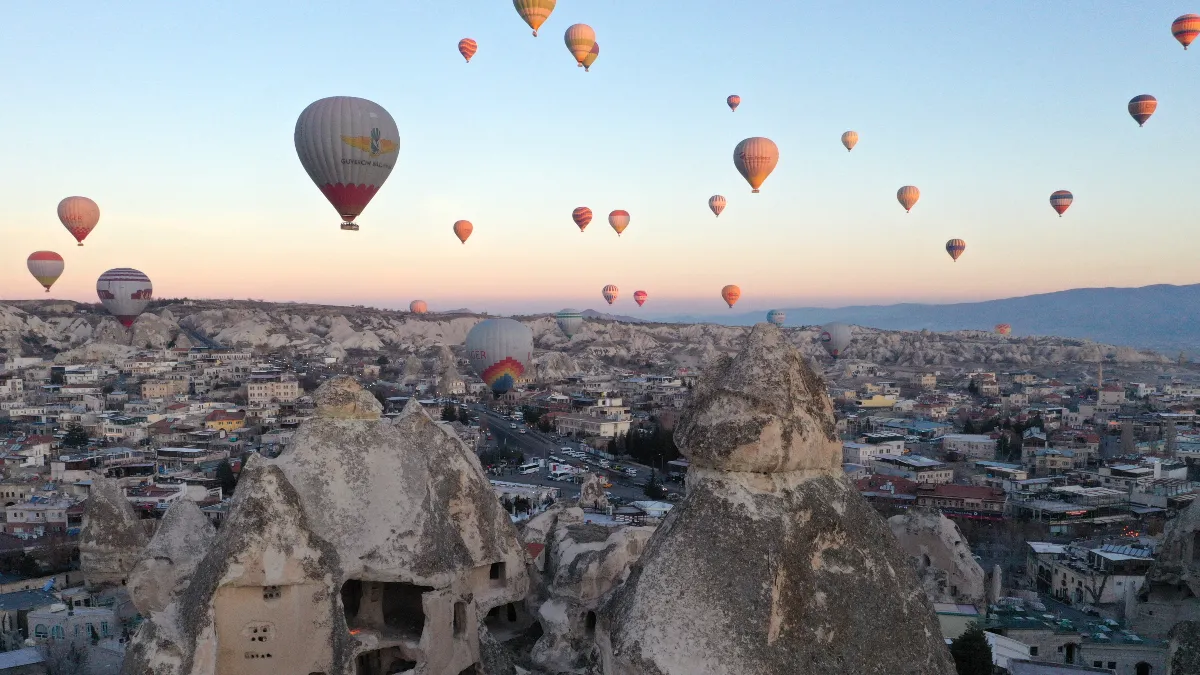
<box><xmin>0</xmin><ymin>300</ymin><xmax>1172</xmax><ymax>378</ymax></box>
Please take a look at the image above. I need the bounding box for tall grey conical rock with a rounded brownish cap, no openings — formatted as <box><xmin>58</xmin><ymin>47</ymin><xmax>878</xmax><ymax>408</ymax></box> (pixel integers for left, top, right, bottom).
<box><xmin>595</xmin><ymin>323</ymin><xmax>954</xmax><ymax>675</ymax></box>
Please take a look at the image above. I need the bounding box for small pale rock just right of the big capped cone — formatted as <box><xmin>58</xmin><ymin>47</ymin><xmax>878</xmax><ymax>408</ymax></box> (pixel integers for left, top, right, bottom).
<box><xmin>888</xmin><ymin>508</ymin><xmax>988</xmax><ymax>609</ymax></box>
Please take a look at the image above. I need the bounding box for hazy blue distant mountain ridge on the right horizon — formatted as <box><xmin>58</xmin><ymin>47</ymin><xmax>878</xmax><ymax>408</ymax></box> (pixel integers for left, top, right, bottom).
<box><xmin>659</xmin><ymin>283</ymin><xmax>1200</xmax><ymax>354</ymax></box>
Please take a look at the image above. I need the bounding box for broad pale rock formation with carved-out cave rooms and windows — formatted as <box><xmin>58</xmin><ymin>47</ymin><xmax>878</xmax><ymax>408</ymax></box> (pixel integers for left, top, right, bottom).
<box><xmin>124</xmin><ymin>378</ymin><xmax>529</xmax><ymax>675</ymax></box>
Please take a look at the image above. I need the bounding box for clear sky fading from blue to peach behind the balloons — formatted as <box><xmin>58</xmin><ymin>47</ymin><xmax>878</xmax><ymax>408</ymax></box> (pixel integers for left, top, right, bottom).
<box><xmin>0</xmin><ymin>0</ymin><xmax>1200</xmax><ymax>312</ymax></box>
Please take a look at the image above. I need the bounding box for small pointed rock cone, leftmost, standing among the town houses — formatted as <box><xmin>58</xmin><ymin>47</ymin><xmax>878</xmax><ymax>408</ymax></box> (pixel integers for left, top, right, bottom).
<box><xmin>79</xmin><ymin>478</ymin><xmax>148</xmax><ymax>586</ymax></box>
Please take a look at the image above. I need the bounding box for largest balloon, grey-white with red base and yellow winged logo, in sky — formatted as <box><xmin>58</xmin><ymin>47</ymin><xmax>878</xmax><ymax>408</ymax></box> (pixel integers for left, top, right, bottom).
<box><xmin>295</xmin><ymin>96</ymin><xmax>400</xmax><ymax>231</ymax></box>
